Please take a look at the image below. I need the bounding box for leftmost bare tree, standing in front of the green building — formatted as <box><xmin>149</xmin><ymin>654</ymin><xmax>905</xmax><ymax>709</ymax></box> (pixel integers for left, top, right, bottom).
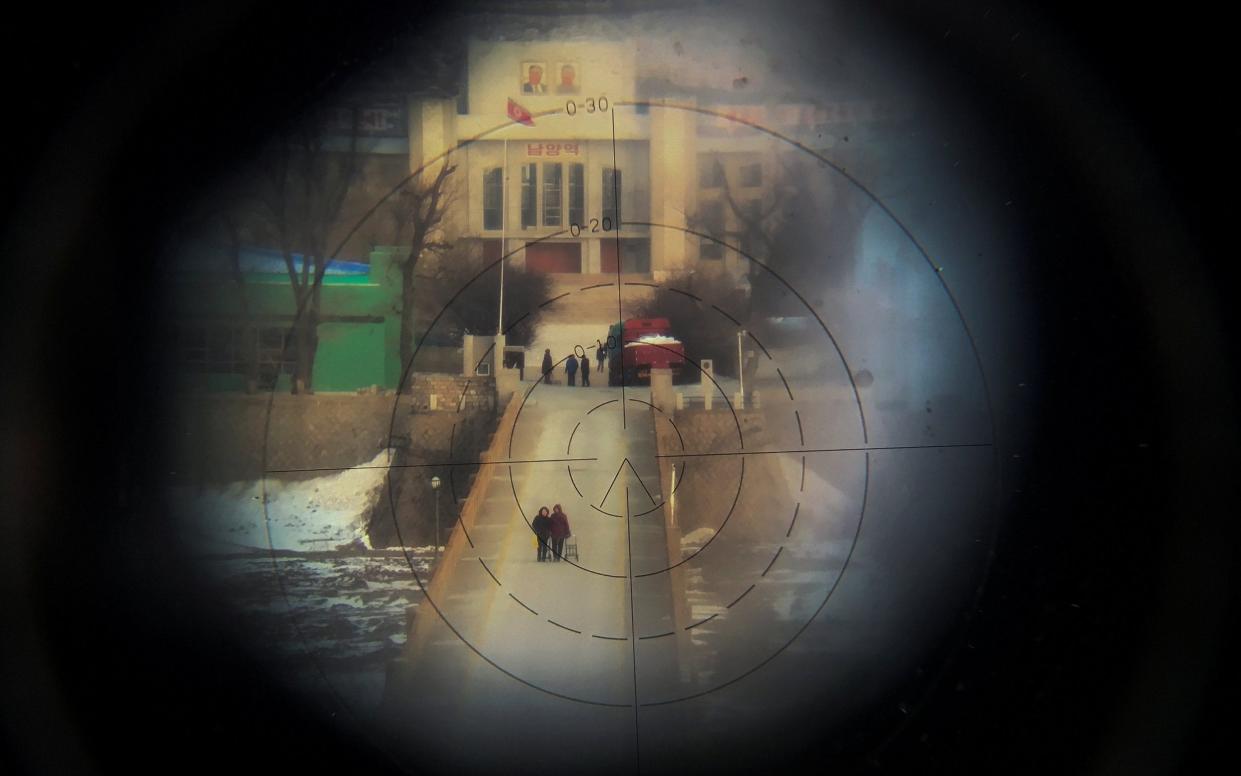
<box><xmin>258</xmin><ymin>108</ymin><xmax>359</xmax><ymax>394</ymax></box>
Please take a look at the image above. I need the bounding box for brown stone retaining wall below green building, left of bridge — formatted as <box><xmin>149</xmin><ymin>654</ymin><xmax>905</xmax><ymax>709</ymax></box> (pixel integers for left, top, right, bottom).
<box><xmin>168</xmin><ymin>384</ymin><xmax>496</xmax><ymax>546</ymax></box>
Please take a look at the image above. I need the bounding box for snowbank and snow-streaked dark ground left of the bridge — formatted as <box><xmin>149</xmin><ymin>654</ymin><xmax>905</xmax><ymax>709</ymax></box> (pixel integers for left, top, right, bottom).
<box><xmin>171</xmin><ymin>451</ymin><xmax>446</xmax><ymax>716</ymax></box>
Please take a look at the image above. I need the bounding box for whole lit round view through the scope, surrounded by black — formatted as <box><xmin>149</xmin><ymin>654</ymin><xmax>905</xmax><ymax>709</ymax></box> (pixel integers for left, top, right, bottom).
<box><xmin>160</xmin><ymin>12</ymin><xmax>999</xmax><ymax>771</ymax></box>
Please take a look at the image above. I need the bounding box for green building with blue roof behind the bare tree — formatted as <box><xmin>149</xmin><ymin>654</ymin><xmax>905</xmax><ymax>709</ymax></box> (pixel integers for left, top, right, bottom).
<box><xmin>172</xmin><ymin>246</ymin><xmax>403</xmax><ymax>392</ymax></box>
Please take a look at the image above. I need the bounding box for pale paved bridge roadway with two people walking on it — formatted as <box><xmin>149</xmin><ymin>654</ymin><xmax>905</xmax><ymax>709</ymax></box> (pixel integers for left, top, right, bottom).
<box><xmin>384</xmin><ymin>384</ymin><xmax>676</xmax><ymax>770</ymax></box>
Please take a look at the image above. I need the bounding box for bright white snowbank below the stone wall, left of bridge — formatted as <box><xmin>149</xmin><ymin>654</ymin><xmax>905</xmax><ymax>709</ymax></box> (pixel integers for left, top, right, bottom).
<box><xmin>172</xmin><ymin>451</ymin><xmax>390</xmax><ymax>554</ymax></box>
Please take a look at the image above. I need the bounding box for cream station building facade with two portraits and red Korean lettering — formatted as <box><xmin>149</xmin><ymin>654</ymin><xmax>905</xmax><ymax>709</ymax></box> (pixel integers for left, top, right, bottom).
<box><xmin>408</xmin><ymin>34</ymin><xmax>893</xmax><ymax>281</ymax></box>
